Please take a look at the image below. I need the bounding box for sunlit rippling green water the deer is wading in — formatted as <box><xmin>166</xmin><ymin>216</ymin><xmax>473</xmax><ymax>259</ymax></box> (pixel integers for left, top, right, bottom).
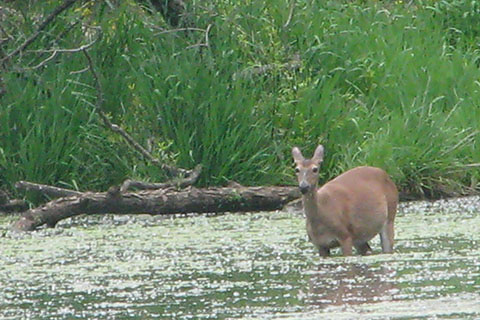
<box><xmin>0</xmin><ymin>197</ymin><xmax>480</xmax><ymax>319</ymax></box>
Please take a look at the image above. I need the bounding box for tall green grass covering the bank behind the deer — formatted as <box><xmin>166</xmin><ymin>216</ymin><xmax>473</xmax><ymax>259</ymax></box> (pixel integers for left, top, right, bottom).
<box><xmin>0</xmin><ymin>0</ymin><xmax>480</xmax><ymax>200</ymax></box>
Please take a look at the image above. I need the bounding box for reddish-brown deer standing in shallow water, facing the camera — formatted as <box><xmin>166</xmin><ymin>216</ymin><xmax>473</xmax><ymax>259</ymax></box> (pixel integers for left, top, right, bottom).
<box><xmin>292</xmin><ymin>145</ymin><xmax>398</xmax><ymax>257</ymax></box>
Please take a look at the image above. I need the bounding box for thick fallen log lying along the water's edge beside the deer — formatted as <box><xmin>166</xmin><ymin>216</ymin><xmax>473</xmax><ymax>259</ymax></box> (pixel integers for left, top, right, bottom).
<box><xmin>12</xmin><ymin>187</ymin><xmax>300</xmax><ymax>231</ymax></box>
